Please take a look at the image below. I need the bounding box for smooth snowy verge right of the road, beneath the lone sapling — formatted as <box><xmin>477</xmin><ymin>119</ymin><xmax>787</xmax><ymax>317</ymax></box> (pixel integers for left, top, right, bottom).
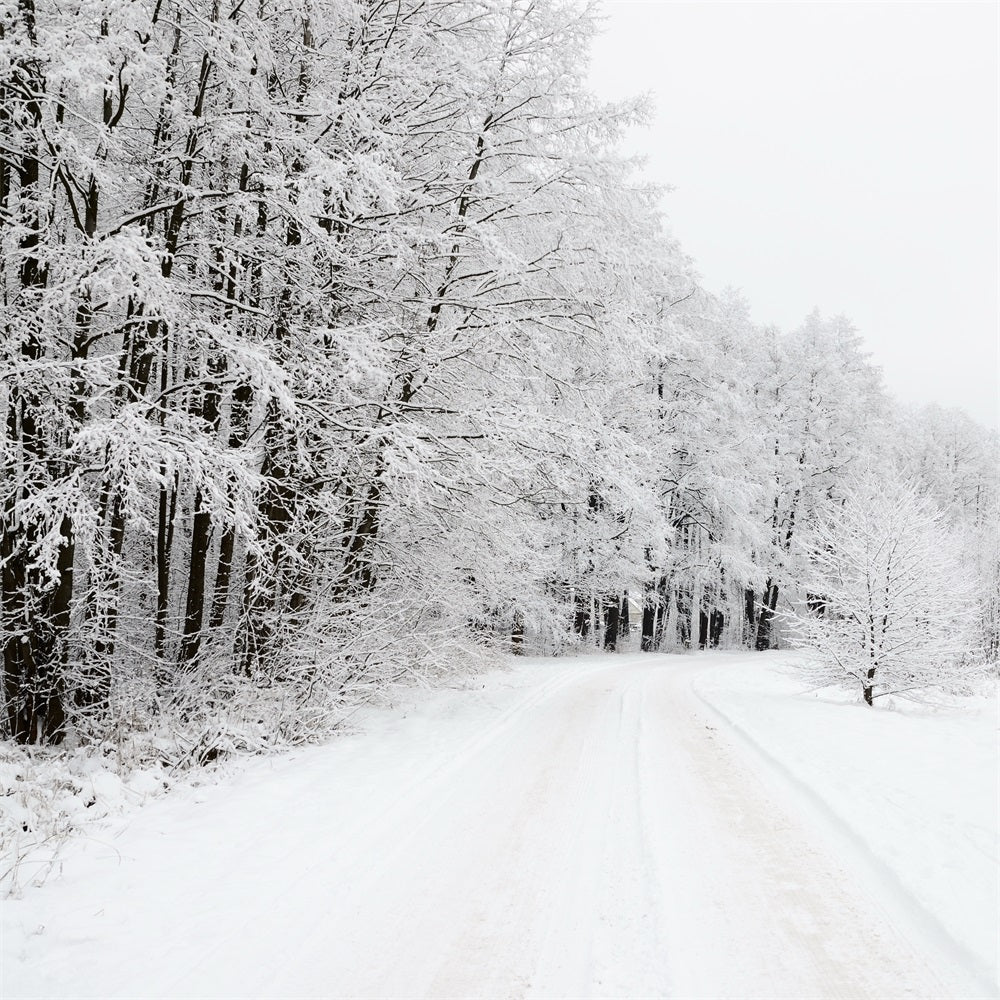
<box><xmin>692</xmin><ymin>654</ymin><xmax>1000</xmax><ymax>983</ymax></box>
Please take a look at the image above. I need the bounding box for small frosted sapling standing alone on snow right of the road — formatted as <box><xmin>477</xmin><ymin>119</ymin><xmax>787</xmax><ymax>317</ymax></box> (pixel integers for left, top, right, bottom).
<box><xmin>790</xmin><ymin>474</ymin><xmax>974</xmax><ymax>705</ymax></box>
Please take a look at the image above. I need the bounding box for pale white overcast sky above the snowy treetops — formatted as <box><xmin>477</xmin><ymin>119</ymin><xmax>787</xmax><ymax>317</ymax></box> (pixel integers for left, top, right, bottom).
<box><xmin>591</xmin><ymin>0</ymin><xmax>1000</xmax><ymax>424</ymax></box>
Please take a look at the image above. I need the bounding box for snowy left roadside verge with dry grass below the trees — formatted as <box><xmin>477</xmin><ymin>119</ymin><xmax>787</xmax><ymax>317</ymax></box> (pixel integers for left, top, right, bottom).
<box><xmin>0</xmin><ymin>658</ymin><xmax>580</xmax><ymax>899</ymax></box>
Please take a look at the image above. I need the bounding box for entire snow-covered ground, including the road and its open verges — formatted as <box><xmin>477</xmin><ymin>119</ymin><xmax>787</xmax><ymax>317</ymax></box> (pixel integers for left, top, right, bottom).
<box><xmin>0</xmin><ymin>654</ymin><xmax>998</xmax><ymax>1000</ymax></box>
